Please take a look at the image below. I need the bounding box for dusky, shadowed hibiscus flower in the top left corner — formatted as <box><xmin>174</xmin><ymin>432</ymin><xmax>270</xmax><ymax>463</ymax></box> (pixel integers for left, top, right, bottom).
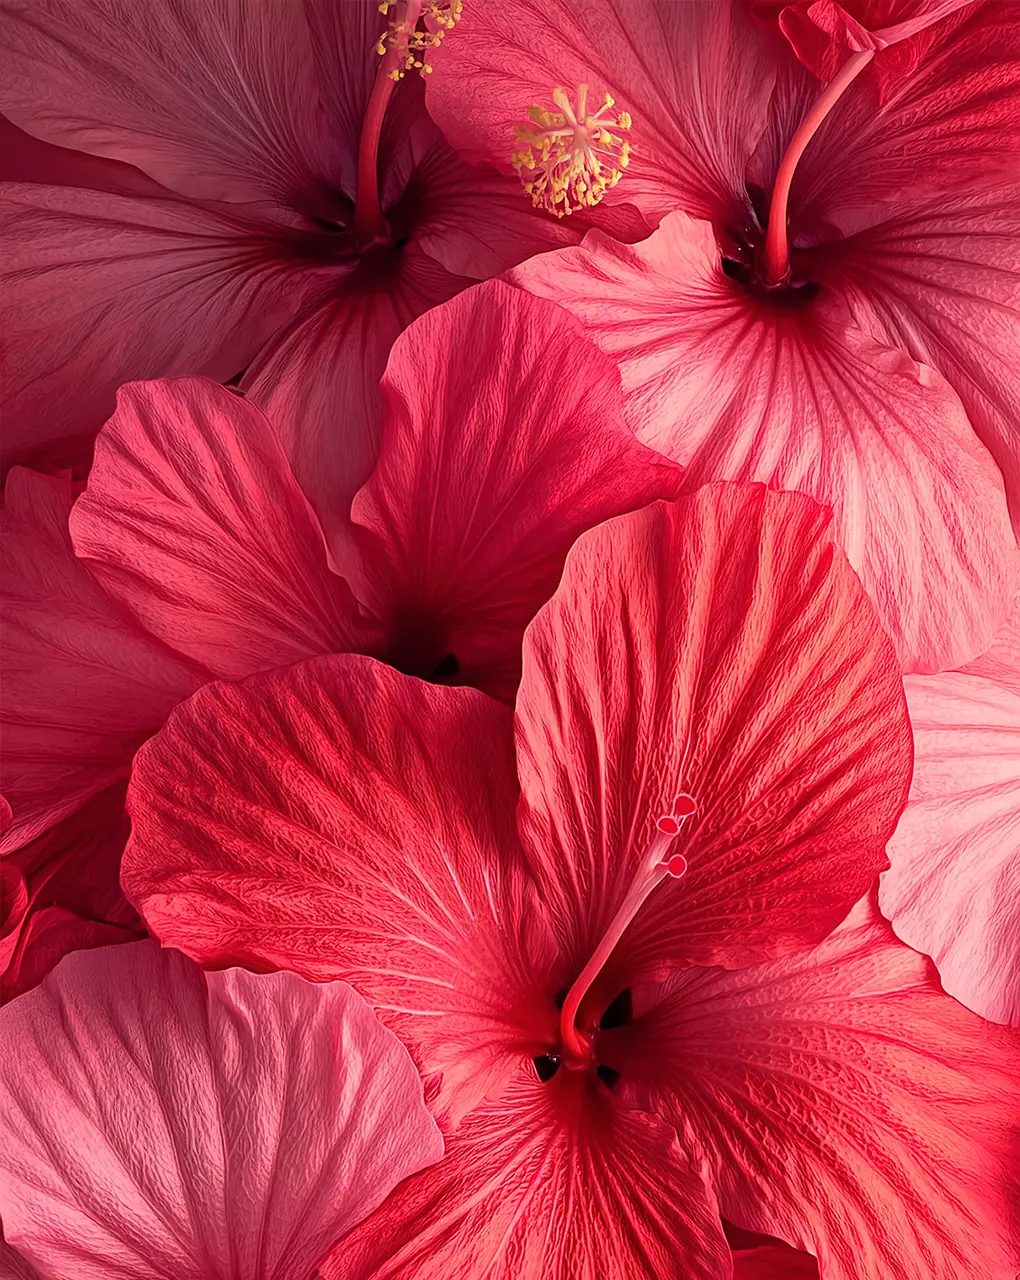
<box><xmin>0</xmin><ymin>0</ymin><xmax>642</xmax><ymax>509</ymax></box>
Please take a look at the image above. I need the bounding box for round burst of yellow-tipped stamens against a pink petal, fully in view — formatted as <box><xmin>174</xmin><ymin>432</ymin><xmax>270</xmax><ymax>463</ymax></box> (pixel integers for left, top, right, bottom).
<box><xmin>511</xmin><ymin>84</ymin><xmax>631</xmax><ymax>218</ymax></box>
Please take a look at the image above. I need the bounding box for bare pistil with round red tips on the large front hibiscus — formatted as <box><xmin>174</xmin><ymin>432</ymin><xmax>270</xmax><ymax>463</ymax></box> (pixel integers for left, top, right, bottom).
<box><xmin>559</xmin><ymin>792</ymin><xmax>697</xmax><ymax>1068</ymax></box>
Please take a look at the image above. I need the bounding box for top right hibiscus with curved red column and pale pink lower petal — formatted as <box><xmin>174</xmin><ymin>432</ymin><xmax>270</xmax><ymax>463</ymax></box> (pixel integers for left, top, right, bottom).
<box><xmin>427</xmin><ymin>0</ymin><xmax>1020</xmax><ymax>671</ymax></box>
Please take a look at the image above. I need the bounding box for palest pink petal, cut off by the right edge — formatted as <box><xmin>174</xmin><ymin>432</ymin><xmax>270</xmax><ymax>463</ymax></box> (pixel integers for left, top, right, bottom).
<box><xmin>879</xmin><ymin>593</ymin><xmax>1020</xmax><ymax>1027</ymax></box>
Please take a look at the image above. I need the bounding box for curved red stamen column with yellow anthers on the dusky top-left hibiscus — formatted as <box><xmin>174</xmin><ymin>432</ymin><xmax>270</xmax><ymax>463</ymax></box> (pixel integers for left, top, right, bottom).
<box><xmin>355</xmin><ymin>0</ymin><xmax>463</xmax><ymax>248</ymax></box>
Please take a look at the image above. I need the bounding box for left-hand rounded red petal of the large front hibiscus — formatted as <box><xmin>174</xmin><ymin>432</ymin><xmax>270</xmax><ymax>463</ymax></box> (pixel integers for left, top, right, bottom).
<box><xmin>122</xmin><ymin>657</ymin><xmax>540</xmax><ymax>1092</ymax></box>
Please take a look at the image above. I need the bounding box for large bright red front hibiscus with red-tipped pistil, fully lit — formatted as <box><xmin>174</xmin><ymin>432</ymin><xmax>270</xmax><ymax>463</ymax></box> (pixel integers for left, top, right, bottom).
<box><xmin>115</xmin><ymin>485</ymin><xmax>1015</xmax><ymax>1280</ymax></box>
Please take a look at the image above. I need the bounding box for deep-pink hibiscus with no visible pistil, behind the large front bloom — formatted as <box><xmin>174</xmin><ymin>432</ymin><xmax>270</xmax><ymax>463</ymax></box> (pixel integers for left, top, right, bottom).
<box><xmin>0</xmin><ymin>282</ymin><xmax>681</xmax><ymax>992</ymax></box>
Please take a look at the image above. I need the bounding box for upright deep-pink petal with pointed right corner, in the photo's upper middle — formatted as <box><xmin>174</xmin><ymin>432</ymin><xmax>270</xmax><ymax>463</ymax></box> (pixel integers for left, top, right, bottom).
<box><xmin>352</xmin><ymin>280</ymin><xmax>681</xmax><ymax>699</ymax></box>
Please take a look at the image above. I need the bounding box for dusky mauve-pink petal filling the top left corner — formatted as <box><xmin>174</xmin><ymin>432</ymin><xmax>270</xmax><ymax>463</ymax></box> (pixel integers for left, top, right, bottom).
<box><xmin>0</xmin><ymin>0</ymin><xmax>328</xmax><ymax>201</ymax></box>
